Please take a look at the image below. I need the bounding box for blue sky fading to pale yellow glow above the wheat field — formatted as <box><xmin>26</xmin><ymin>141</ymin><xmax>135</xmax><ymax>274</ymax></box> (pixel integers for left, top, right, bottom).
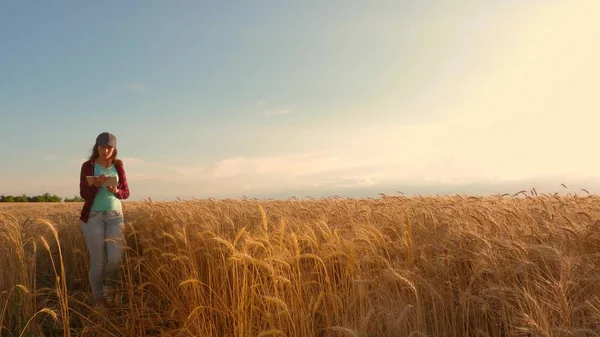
<box><xmin>0</xmin><ymin>0</ymin><xmax>600</xmax><ymax>200</ymax></box>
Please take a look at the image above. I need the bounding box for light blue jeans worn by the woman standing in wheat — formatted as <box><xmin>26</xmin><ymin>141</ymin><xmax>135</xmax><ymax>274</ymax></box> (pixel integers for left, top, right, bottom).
<box><xmin>83</xmin><ymin>211</ymin><xmax>124</xmax><ymax>299</ymax></box>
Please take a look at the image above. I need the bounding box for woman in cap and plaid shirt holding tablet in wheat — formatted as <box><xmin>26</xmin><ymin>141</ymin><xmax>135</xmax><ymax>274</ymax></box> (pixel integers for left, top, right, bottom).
<box><xmin>79</xmin><ymin>132</ymin><xmax>129</xmax><ymax>306</ymax></box>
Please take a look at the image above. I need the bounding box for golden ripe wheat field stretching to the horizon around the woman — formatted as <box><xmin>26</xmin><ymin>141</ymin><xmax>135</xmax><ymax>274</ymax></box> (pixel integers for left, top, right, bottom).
<box><xmin>0</xmin><ymin>193</ymin><xmax>600</xmax><ymax>337</ymax></box>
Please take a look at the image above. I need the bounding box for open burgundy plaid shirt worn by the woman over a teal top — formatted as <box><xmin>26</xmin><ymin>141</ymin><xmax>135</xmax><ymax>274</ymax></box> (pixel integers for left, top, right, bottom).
<box><xmin>79</xmin><ymin>160</ymin><xmax>129</xmax><ymax>222</ymax></box>
